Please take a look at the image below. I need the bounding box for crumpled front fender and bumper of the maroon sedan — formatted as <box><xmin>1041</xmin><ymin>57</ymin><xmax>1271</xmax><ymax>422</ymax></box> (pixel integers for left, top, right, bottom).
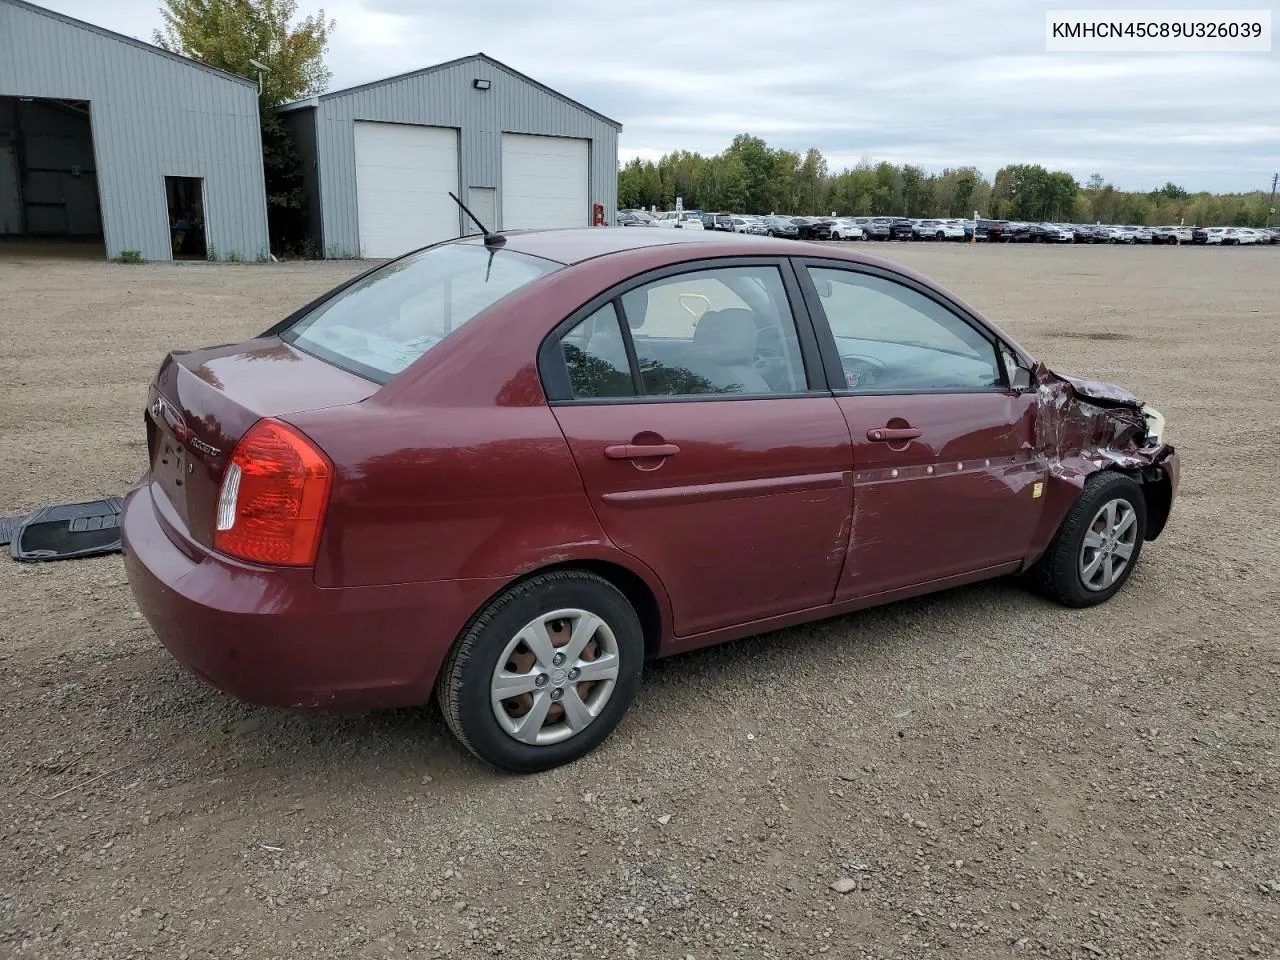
<box><xmin>1033</xmin><ymin>364</ymin><xmax>1179</xmax><ymax>554</ymax></box>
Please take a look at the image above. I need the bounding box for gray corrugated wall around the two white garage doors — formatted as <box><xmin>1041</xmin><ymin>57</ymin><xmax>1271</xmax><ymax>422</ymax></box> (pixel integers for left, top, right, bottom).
<box><xmin>295</xmin><ymin>58</ymin><xmax>618</xmax><ymax>256</ymax></box>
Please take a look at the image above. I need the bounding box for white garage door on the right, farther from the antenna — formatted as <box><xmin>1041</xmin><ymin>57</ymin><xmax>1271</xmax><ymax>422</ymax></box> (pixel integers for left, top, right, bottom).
<box><xmin>502</xmin><ymin>133</ymin><xmax>591</xmax><ymax>230</ymax></box>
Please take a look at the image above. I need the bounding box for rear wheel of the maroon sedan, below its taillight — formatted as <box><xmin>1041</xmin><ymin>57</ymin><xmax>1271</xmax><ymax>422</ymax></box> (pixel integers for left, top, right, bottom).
<box><xmin>436</xmin><ymin>570</ymin><xmax>644</xmax><ymax>773</ymax></box>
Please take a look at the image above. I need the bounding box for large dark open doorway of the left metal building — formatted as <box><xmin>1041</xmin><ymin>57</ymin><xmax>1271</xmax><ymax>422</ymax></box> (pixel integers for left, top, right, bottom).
<box><xmin>0</xmin><ymin>96</ymin><xmax>102</xmax><ymax>257</ymax></box>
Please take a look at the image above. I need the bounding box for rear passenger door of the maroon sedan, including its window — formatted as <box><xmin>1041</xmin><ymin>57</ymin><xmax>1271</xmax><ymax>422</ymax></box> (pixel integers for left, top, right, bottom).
<box><xmin>540</xmin><ymin>259</ymin><xmax>852</xmax><ymax>637</ymax></box>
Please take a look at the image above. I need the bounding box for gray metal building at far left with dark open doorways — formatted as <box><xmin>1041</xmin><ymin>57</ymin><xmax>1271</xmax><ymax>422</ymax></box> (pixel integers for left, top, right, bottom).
<box><xmin>0</xmin><ymin>0</ymin><xmax>269</xmax><ymax>260</ymax></box>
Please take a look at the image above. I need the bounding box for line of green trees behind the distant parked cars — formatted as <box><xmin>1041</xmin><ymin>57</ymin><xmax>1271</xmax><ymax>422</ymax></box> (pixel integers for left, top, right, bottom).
<box><xmin>618</xmin><ymin>133</ymin><xmax>1268</xmax><ymax>227</ymax></box>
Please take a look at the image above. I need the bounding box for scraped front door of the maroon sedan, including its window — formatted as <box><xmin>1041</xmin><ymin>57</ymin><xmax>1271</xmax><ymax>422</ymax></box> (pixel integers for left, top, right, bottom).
<box><xmin>801</xmin><ymin>259</ymin><xmax>1046</xmax><ymax>600</ymax></box>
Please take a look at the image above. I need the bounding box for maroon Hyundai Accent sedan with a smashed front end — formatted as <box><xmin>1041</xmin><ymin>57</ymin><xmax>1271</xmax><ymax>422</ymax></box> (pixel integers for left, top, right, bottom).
<box><xmin>124</xmin><ymin>229</ymin><xmax>1178</xmax><ymax>771</ymax></box>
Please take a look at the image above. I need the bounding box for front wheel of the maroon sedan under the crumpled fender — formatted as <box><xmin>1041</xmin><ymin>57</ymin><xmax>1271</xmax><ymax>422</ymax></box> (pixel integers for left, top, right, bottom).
<box><xmin>1028</xmin><ymin>471</ymin><xmax>1147</xmax><ymax>607</ymax></box>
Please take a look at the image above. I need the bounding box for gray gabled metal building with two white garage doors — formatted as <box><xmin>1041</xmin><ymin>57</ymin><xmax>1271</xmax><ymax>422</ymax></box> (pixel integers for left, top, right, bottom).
<box><xmin>280</xmin><ymin>54</ymin><xmax>622</xmax><ymax>257</ymax></box>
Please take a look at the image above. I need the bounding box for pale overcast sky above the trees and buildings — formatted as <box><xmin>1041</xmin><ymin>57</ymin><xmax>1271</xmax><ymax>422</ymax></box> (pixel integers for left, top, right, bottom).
<box><xmin>35</xmin><ymin>0</ymin><xmax>1280</xmax><ymax>191</ymax></box>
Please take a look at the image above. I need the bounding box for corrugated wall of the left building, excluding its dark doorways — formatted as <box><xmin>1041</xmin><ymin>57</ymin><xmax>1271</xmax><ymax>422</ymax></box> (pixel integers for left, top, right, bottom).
<box><xmin>0</xmin><ymin>0</ymin><xmax>269</xmax><ymax>260</ymax></box>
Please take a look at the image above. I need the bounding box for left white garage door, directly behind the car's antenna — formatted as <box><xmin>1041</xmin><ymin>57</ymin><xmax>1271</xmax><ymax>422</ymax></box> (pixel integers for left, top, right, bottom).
<box><xmin>356</xmin><ymin>120</ymin><xmax>458</xmax><ymax>257</ymax></box>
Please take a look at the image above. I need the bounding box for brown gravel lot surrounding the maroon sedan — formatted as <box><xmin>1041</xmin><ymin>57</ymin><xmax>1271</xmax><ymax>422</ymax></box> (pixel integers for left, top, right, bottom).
<box><xmin>0</xmin><ymin>244</ymin><xmax>1280</xmax><ymax>960</ymax></box>
